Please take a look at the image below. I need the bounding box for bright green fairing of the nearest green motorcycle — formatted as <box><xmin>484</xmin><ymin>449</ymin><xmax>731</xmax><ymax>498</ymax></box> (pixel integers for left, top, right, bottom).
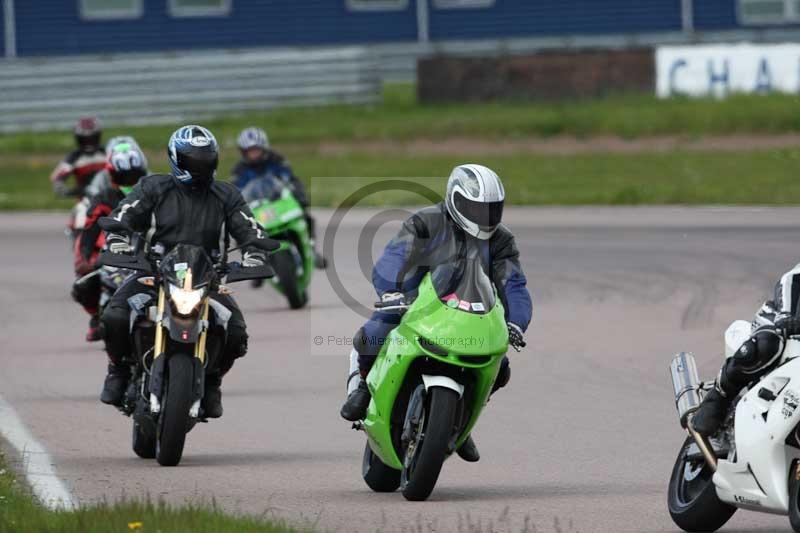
<box><xmin>364</xmin><ymin>274</ymin><xmax>508</xmax><ymax>470</ymax></box>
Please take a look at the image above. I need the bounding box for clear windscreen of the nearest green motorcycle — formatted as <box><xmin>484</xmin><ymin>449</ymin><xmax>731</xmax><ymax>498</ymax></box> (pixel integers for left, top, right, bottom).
<box><xmin>431</xmin><ymin>241</ymin><xmax>497</xmax><ymax>315</ymax></box>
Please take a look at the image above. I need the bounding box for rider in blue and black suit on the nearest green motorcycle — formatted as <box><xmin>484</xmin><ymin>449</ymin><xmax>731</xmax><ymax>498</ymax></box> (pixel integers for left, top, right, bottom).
<box><xmin>340</xmin><ymin>164</ymin><xmax>532</xmax><ymax>462</ymax></box>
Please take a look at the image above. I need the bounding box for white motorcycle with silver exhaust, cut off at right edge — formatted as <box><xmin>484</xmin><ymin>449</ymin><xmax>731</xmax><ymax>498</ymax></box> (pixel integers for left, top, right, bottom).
<box><xmin>667</xmin><ymin>320</ymin><xmax>800</xmax><ymax>533</ymax></box>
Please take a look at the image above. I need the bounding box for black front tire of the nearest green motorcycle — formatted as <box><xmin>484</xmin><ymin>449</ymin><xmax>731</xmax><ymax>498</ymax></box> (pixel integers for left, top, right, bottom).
<box><xmin>403</xmin><ymin>387</ymin><xmax>458</xmax><ymax>501</ymax></box>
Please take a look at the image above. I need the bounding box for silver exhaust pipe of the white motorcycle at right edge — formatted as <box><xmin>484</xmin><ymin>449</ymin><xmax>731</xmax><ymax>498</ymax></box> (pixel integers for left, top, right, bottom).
<box><xmin>669</xmin><ymin>352</ymin><xmax>717</xmax><ymax>472</ymax></box>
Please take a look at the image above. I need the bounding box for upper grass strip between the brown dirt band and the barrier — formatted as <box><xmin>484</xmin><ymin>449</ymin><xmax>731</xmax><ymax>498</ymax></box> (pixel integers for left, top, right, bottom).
<box><xmin>0</xmin><ymin>84</ymin><xmax>800</xmax><ymax>156</ymax></box>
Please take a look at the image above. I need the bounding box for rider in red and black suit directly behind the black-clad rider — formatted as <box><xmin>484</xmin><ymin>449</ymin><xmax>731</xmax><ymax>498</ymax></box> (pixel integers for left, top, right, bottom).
<box><xmin>72</xmin><ymin>142</ymin><xmax>147</xmax><ymax>342</ymax></box>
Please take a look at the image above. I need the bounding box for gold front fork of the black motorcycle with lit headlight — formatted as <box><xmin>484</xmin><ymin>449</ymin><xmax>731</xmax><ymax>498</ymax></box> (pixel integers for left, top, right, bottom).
<box><xmin>150</xmin><ymin>287</ymin><xmax>210</xmax><ymax>418</ymax></box>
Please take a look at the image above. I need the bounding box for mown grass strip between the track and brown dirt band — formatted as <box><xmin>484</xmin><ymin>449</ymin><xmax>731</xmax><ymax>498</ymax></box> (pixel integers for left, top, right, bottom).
<box><xmin>0</xmin><ymin>149</ymin><xmax>800</xmax><ymax>209</ymax></box>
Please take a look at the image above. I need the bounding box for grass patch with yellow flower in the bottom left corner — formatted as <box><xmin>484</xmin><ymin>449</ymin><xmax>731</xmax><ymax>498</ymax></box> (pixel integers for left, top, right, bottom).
<box><xmin>0</xmin><ymin>448</ymin><xmax>301</xmax><ymax>533</ymax></box>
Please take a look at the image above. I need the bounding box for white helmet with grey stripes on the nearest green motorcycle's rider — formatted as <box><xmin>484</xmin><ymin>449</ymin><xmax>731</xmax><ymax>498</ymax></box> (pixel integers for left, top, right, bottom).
<box><xmin>445</xmin><ymin>164</ymin><xmax>506</xmax><ymax>240</ymax></box>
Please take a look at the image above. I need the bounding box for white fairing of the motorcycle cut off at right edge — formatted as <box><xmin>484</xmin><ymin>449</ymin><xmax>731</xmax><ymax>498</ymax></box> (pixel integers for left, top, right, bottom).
<box><xmin>714</xmin><ymin>354</ymin><xmax>800</xmax><ymax>514</ymax></box>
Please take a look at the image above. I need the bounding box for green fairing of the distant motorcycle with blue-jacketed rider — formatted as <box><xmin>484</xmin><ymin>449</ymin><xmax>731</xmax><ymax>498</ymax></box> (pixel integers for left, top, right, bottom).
<box><xmin>250</xmin><ymin>188</ymin><xmax>314</xmax><ymax>293</ymax></box>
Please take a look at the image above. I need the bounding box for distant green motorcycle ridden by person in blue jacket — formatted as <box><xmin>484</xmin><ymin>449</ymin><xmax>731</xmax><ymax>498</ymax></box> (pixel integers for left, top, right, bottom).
<box><xmin>242</xmin><ymin>176</ymin><xmax>314</xmax><ymax>309</ymax></box>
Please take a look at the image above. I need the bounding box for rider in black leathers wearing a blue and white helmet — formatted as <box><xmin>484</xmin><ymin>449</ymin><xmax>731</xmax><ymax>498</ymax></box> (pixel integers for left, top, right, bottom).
<box><xmin>100</xmin><ymin>125</ymin><xmax>279</xmax><ymax>418</ymax></box>
